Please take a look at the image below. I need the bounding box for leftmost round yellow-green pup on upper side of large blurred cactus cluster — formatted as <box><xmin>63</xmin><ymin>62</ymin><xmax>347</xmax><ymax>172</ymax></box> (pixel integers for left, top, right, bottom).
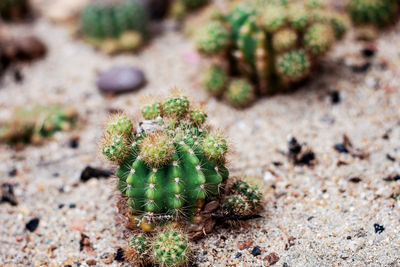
<box><xmin>196</xmin><ymin>21</ymin><xmax>229</xmax><ymax>55</ymax></box>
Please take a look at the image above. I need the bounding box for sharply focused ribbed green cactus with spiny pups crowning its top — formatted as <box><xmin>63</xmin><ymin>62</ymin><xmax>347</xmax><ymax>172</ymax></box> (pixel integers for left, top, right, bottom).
<box><xmin>102</xmin><ymin>95</ymin><xmax>229</xmax><ymax>230</ymax></box>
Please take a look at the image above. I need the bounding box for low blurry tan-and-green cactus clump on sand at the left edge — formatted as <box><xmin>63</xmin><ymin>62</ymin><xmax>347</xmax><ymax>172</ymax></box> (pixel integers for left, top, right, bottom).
<box><xmin>0</xmin><ymin>105</ymin><xmax>77</xmax><ymax>147</ymax></box>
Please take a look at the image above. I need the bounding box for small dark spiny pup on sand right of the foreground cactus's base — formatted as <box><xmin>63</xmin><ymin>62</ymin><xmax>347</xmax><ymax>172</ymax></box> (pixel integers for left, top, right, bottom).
<box><xmin>223</xmin><ymin>180</ymin><xmax>261</xmax><ymax>215</ymax></box>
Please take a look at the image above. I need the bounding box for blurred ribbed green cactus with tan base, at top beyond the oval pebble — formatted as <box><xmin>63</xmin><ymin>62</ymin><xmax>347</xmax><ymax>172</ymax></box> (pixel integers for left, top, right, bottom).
<box><xmin>81</xmin><ymin>0</ymin><xmax>148</xmax><ymax>54</ymax></box>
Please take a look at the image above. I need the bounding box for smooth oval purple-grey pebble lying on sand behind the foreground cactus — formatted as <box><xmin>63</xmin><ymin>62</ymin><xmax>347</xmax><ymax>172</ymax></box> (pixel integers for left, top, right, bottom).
<box><xmin>97</xmin><ymin>67</ymin><xmax>146</xmax><ymax>94</ymax></box>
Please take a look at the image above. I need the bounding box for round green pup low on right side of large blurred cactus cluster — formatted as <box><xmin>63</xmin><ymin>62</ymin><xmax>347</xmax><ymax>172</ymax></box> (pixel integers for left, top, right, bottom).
<box><xmin>276</xmin><ymin>50</ymin><xmax>310</xmax><ymax>81</ymax></box>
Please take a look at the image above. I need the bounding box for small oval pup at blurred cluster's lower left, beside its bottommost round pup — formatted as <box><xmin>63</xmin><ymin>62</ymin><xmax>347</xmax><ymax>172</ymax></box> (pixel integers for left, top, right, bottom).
<box><xmin>203</xmin><ymin>65</ymin><xmax>228</xmax><ymax>95</ymax></box>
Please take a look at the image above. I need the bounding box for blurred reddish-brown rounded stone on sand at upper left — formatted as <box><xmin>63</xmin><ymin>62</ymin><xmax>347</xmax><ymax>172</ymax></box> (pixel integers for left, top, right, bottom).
<box><xmin>15</xmin><ymin>36</ymin><xmax>47</xmax><ymax>60</ymax></box>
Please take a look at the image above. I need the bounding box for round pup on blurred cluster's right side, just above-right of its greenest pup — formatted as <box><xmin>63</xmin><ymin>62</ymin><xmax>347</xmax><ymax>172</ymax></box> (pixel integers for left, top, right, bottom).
<box><xmin>304</xmin><ymin>23</ymin><xmax>335</xmax><ymax>56</ymax></box>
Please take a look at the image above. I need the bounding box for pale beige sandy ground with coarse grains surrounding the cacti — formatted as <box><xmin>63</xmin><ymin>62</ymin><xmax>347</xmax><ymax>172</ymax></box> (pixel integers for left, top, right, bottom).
<box><xmin>0</xmin><ymin>7</ymin><xmax>400</xmax><ymax>267</ymax></box>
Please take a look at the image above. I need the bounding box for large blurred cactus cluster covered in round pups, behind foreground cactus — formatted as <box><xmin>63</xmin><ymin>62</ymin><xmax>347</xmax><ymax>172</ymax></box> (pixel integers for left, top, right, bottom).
<box><xmin>195</xmin><ymin>0</ymin><xmax>348</xmax><ymax>107</ymax></box>
